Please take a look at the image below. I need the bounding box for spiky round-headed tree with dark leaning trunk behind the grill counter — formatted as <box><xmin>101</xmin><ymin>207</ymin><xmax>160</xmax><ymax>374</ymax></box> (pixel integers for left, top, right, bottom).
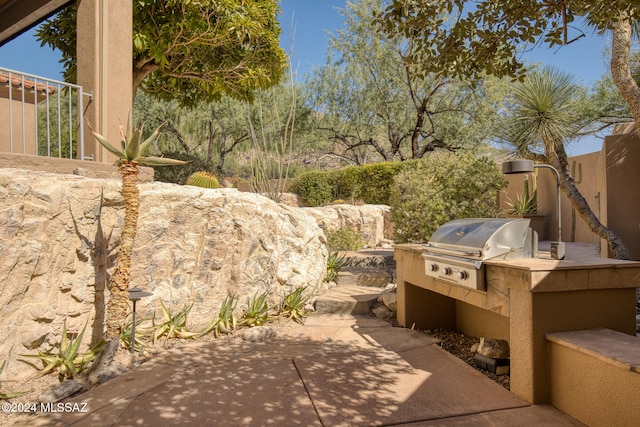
<box><xmin>504</xmin><ymin>68</ymin><xmax>629</xmax><ymax>259</ymax></box>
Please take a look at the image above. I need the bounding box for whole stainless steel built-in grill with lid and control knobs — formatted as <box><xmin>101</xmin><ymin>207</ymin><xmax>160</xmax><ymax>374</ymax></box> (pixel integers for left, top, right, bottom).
<box><xmin>422</xmin><ymin>218</ymin><xmax>537</xmax><ymax>291</ymax></box>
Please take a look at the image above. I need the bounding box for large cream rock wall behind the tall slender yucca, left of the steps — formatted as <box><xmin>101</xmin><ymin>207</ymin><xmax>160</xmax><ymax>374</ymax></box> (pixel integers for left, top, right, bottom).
<box><xmin>0</xmin><ymin>169</ymin><xmax>327</xmax><ymax>378</ymax></box>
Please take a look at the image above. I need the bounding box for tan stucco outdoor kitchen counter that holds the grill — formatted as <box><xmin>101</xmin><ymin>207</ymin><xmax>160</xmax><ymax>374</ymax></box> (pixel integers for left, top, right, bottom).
<box><xmin>394</xmin><ymin>243</ymin><xmax>640</xmax><ymax>403</ymax></box>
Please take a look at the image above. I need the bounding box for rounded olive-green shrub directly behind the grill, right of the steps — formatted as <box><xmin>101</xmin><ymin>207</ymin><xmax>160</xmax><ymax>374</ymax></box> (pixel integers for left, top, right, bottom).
<box><xmin>390</xmin><ymin>152</ymin><xmax>506</xmax><ymax>242</ymax></box>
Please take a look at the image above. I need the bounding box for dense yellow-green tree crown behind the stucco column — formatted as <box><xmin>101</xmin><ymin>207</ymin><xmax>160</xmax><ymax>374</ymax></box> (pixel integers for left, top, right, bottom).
<box><xmin>37</xmin><ymin>0</ymin><xmax>286</xmax><ymax>107</ymax></box>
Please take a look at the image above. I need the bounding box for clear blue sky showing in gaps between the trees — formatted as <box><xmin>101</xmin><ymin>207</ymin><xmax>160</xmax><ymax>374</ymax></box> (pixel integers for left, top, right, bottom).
<box><xmin>0</xmin><ymin>0</ymin><xmax>609</xmax><ymax>155</ymax></box>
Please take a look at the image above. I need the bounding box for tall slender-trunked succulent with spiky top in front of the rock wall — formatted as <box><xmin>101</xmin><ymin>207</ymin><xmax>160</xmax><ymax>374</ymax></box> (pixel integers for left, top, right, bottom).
<box><xmin>93</xmin><ymin>122</ymin><xmax>186</xmax><ymax>339</ymax></box>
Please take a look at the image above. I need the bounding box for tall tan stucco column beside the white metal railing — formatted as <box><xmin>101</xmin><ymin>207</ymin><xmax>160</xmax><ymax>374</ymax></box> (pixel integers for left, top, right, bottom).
<box><xmin>77</xmin><ymin>0</ymin><xmax>133</xmax><ymax>163</ymax></box>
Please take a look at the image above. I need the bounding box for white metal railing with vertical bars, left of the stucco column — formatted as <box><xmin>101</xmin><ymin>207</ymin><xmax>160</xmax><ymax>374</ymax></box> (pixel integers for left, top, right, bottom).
<box><xmin>0</xmin><ymin>67</ymin><xmax>93</xmax><ymax>160</ymax></box>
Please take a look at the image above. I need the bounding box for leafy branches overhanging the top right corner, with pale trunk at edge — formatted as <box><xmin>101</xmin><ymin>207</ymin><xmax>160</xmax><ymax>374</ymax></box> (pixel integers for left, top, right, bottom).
<box><xmin>377</xmin><ymin>0</ymin><xmax>640</xmax><ymax>139</ymax></box>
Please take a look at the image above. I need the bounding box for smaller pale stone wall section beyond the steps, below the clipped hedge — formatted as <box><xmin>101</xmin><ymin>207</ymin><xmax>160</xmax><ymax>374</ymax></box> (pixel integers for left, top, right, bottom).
<box><xmin>301</xmin><ymin>204</ymin><xmax>393</xmax><ymax>248</ymax></box>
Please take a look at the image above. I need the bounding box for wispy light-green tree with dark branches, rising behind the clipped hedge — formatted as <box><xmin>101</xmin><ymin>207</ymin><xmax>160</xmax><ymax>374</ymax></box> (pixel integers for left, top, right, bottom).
<box><xmin>308</xmin><ymin>0</ymin><xmax>504</xmax><ymax>164</ymax></box>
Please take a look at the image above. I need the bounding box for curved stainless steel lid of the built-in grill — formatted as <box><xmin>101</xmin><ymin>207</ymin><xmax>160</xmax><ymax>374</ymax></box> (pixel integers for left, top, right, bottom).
<box><xmin>426</xmin><ymin>218</ymin><xmax>531</xmax><ymax>260</ymax></box>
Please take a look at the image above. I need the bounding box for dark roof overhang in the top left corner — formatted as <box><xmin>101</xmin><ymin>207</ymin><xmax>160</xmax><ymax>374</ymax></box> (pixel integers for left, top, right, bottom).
<box><xmin>0</xmin><ymin>0</ymin><xmax>75</xmax><ymax>46</ymax></box>
